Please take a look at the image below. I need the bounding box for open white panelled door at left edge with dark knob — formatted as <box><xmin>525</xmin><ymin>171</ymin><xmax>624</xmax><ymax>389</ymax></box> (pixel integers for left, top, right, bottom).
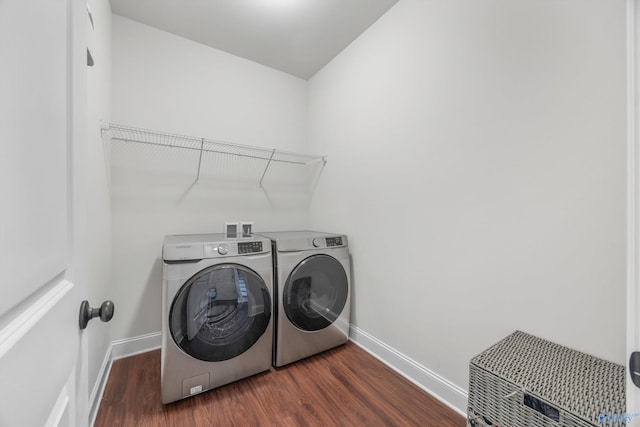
<box><xmin>0</xmin><ymin>0</ymin><xmax>87</xmax><ymax>427</ymax></box>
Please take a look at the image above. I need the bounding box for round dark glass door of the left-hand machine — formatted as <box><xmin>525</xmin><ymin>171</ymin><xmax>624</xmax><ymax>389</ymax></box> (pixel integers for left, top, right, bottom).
<box><xmin>169</xmin><ymin>264</ymin><xmax>271</xmax><ymax>362</ymax></box>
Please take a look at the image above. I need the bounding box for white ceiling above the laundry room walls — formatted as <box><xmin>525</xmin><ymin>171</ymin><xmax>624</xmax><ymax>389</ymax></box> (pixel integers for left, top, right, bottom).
<box><xmin>110</xmin><ymin>0</ymin><xmax>398</xmax><ymax>79</ymax></box>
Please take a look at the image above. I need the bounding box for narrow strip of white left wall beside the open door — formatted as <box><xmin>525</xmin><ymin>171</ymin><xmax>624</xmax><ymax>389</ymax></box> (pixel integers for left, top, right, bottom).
<box><xmin>85</xmin><ymin>0</ymin><xmax>112</xmax><ymax>408</ymax></box>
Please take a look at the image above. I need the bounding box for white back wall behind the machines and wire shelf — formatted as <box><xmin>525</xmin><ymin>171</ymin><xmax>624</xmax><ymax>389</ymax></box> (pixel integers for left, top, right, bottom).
<box><xmin>112</xmin><ymin>15</ymin><xmax>308</xmax><ymax>339</ymax></box>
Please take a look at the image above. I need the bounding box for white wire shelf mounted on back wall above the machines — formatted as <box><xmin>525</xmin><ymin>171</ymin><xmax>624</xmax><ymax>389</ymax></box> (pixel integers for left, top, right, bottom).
<box><xmin>105</xmin><ymin>123</ymin><xmax>327</xmax><ymax>186</ymax></box>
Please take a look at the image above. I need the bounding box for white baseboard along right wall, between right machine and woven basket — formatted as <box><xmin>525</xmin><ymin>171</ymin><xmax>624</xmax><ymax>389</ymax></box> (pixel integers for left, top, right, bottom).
<box><xmin>349</xmin><ymin>325</ymin><xmax>469</xmax><ymax>417</ymax></box>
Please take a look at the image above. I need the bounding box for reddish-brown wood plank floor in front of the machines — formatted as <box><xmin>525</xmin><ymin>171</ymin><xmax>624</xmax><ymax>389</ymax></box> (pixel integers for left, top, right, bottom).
<box><xmin>95</xmin><ymin>342</ymin><xmax>466</xmax><ymax>427</ymax></box>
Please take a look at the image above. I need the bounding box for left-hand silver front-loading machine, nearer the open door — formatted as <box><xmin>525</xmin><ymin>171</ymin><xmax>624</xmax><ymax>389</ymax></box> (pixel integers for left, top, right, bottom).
<box><xmin>161</xmin><ymin>234</ymin><xmax>273</xmax><ymax>403</ymax></box>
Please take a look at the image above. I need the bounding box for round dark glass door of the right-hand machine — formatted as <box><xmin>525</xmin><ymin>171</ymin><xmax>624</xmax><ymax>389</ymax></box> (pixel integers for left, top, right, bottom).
<box><xmin>282</xmin><ymin>255</ymin><xmax>349</xmax><ymax>331</ymax></box>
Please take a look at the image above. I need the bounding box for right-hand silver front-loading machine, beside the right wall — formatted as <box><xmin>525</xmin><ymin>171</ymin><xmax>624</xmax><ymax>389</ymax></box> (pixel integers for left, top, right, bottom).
<box><xmin>260</xmin><ymin>231</ymin><xmax>351</xmax><ymax>367</ymax></box>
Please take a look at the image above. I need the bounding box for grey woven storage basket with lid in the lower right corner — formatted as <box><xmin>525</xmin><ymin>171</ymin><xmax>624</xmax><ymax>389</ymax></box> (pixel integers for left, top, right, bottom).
<box><xmin>467</xmin><ymin>331</ymin><xmax>627</xmax><ymax>427</ymax></box>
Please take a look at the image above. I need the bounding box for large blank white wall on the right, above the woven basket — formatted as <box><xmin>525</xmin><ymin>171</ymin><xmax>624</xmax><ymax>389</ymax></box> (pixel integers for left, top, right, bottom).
<box><xmin>308</xmin><ymin>0</ymin><xmax>625</xmax><ymax>394</ymax></box>
